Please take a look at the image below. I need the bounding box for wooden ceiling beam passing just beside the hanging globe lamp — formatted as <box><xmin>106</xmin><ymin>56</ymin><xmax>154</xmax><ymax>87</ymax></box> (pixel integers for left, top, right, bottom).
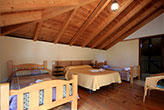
<box><xmin>82</xmin><ymin>0</ymin><xmax>134</xmax><ymax>47</ymax></box>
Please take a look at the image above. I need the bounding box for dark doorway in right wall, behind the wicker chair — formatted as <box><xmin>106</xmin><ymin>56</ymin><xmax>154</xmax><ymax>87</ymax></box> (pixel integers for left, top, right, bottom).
<box><xmin>139</xmin><ymin>35</ymin><xmax>164</xmax><ymax>79</ymax></box>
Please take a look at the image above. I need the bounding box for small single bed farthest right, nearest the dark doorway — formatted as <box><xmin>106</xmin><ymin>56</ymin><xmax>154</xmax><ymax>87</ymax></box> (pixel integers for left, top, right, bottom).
<box><xmin>95</xmin><ymin>61</ymin><xmax>140</xmax><ymax>84</ymax></box>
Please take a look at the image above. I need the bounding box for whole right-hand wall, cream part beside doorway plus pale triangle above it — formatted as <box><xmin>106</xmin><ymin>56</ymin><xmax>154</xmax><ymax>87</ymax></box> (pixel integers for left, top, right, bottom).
<box><xmin>107</xmin><ymin>13</ymin><xmax>164</xmax><ymax>67</ymax></box>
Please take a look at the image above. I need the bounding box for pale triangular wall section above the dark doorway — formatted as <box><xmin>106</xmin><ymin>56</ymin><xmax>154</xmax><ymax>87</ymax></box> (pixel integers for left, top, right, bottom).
<box><xmin>126</xmin><ymin>13</ymin><xmax>164</xmax><ymax>39</ymax></box>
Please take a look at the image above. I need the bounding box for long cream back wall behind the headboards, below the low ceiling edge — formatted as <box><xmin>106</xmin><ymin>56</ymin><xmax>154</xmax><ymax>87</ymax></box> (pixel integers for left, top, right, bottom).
<box><xmin>0</xmin><ymin>36</ymin><xmax>106</xmax><ymax>81</ymax></box>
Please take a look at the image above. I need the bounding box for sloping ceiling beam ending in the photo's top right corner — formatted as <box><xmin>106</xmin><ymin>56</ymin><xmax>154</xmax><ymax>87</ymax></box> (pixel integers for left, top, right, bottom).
<box><xmin>98</xmin><ymin>1</ymin><xmax>162</xmax><ymax>49</ymax></box>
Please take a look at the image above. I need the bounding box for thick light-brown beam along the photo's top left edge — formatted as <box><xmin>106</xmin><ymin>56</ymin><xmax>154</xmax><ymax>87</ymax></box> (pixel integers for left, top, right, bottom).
<box><xmin>0</xmin><ymin>0</ymin><xmax>83</xmax><ymax>13</ymax></box>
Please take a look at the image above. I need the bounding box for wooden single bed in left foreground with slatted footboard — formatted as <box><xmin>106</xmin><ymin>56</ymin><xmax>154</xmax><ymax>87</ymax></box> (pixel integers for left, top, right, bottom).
<box><xmin>0</xmin><ymin>61</ymin><xmax>77</xmax><ymax>110</ymax></box>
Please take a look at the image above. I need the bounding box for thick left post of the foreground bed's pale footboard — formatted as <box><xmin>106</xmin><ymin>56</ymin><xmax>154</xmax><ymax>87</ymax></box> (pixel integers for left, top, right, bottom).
<box><xmin>0</xmin><ymin>83</ymin><xmax>9</xmax><ymax>110</ymax></box>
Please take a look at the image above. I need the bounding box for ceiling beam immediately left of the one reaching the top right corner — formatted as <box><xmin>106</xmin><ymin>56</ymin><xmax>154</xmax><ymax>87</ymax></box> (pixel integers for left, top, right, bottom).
<box><xmin>91</xmin><ymin>0</ymin><xmax>152</xmax><ymax>48</ymax></box>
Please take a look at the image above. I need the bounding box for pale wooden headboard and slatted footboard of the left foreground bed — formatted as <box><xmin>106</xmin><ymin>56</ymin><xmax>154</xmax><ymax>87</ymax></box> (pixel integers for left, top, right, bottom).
<box><xmin>0</xmin><ymin>61</ymin><xmax>77</xmax><ymax>110</ymax></box>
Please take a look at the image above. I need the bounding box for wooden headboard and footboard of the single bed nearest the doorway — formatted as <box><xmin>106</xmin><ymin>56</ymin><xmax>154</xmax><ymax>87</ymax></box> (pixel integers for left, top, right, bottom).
<box><xmin>95</xmin><ymin>61</ymin><xmax>140</xmax><ymax>84</ymax></box>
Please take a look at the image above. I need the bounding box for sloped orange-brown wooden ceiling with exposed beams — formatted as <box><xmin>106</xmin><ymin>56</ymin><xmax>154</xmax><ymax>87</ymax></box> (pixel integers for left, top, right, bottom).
<box><xmin>0</xmin><ymin>0</ymin><xmax>164</xmax><ymax>50</ymax></box>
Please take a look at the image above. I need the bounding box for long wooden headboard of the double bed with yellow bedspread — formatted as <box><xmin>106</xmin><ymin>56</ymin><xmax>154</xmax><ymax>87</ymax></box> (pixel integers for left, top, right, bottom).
<box><xmin>55</xmin><ymin>60</ymin><xmax>92</xmax><ymax>68</ymax></box>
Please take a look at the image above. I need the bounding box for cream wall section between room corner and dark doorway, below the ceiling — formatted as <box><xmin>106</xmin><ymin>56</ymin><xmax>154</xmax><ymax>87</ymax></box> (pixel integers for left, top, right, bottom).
<box><xmin>107</xmin><ymin>39</ymin><xmax>139</xmax><ymax>67</ymax></box>
